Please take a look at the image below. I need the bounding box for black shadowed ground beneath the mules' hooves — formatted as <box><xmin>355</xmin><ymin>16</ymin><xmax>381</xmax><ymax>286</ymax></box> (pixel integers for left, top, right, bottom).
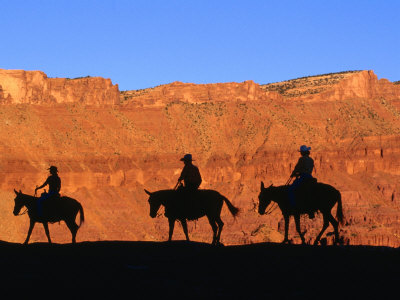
<box><xmin>0</xmin><ymin>241</ymin><xmax>400</xmax><ymax>299</ymax></box>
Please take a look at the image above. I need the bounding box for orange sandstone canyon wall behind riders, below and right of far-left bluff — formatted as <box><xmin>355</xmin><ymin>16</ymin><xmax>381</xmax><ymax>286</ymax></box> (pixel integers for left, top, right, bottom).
<box><xmin>0</xmin><ymin>71</ymin><xmax>400</xmax><ymax>247</ymax></box>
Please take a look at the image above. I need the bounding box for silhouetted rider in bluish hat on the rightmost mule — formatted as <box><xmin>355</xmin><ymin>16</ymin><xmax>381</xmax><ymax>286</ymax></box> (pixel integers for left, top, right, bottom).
<box><xmin>289</xmin><ymin>145</ymin><xmax>314</xmax><ymax>218</ymax></box>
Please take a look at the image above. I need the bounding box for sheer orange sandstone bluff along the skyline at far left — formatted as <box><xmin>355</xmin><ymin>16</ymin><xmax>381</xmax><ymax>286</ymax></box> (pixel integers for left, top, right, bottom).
<box><xmin>0</xmin><ymin>69</ymin><xmax>119</xmax><ymax>105</ymax></box>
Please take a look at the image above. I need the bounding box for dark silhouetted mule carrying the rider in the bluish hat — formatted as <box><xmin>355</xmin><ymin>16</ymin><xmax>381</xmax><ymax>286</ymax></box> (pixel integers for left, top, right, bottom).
<box><xmin>258</xmin><ymin>182</ymin><xmax>344</xmax><ymax>245</ymax></box>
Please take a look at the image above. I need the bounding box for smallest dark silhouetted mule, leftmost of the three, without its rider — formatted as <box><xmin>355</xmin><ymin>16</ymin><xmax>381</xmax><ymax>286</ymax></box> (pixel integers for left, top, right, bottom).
<box><xmin>13</xmin><ymin>190</ymin><xmax>85</xmax><ymax>244</ymax></box>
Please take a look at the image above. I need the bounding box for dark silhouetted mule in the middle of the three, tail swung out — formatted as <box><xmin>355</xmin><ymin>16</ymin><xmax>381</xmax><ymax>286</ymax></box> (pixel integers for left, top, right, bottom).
<box><xmin>145</xmin><ymin>190</ymin><xmax>239</xmax><ymax>245</ymax></box>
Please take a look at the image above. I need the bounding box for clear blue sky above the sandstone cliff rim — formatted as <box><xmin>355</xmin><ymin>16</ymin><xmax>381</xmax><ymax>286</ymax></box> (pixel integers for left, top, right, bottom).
<box><xmin>0</xmin><ymin>0</ymin><xmax>400</xmax><ymax>90</ymax></box>
